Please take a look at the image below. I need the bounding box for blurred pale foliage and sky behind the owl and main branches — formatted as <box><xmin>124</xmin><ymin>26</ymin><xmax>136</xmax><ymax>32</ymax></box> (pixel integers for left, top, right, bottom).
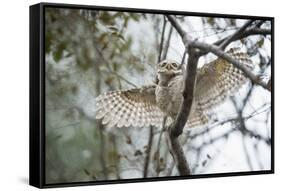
<box><xmin>45</xmin><ymin>8</ymin><xmax>271</xmax><ymax>183</ymax></box>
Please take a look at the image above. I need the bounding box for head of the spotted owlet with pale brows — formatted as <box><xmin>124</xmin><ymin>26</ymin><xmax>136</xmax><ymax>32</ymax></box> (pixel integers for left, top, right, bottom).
<box><xmin>157</xmin><ymin>60</ymin><xmax>182</xmax><ymax>76</ymax></box>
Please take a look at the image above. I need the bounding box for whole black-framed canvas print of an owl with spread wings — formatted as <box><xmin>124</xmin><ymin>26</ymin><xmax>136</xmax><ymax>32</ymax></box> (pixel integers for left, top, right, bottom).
<box><xmin>30</xmin><ymin>3</ymin><xmax>274</xmax><ymax>188</ymax></box>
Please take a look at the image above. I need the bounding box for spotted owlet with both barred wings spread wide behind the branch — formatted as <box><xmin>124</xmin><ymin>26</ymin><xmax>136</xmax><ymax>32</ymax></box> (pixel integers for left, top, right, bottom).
<box><xmin>96</xmin><ymin>48</ymin><xmax>253</xmax><ymax>128</ymax></box>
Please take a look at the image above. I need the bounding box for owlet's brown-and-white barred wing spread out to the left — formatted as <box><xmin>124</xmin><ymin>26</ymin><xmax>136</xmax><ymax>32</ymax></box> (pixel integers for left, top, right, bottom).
<box><xmin>96</xmin><ymin>85</ymin><xmax>164</xmax><ymax>128</ymax></box>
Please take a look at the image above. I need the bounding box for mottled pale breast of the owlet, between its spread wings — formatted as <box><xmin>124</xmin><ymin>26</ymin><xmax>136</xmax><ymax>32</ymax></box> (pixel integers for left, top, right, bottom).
<box><xmin>155</xmin><ymin>75</ymin><xmax>183</xmax><ymax>119</ymax></box>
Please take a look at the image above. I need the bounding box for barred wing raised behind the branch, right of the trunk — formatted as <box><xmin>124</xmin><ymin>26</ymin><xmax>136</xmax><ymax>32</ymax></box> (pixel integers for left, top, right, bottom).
<box><xmin>194</xmin><ymin>48</ymin><xmax>253</xmax><ymax>110</ymax></box>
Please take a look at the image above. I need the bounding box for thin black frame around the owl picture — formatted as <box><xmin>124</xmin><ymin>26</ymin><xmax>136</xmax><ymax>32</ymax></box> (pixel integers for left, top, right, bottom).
<box><xmin>29</xmin><ymin>3</ymin><xmax>274</xmax><ymax>188</ymax></box>
